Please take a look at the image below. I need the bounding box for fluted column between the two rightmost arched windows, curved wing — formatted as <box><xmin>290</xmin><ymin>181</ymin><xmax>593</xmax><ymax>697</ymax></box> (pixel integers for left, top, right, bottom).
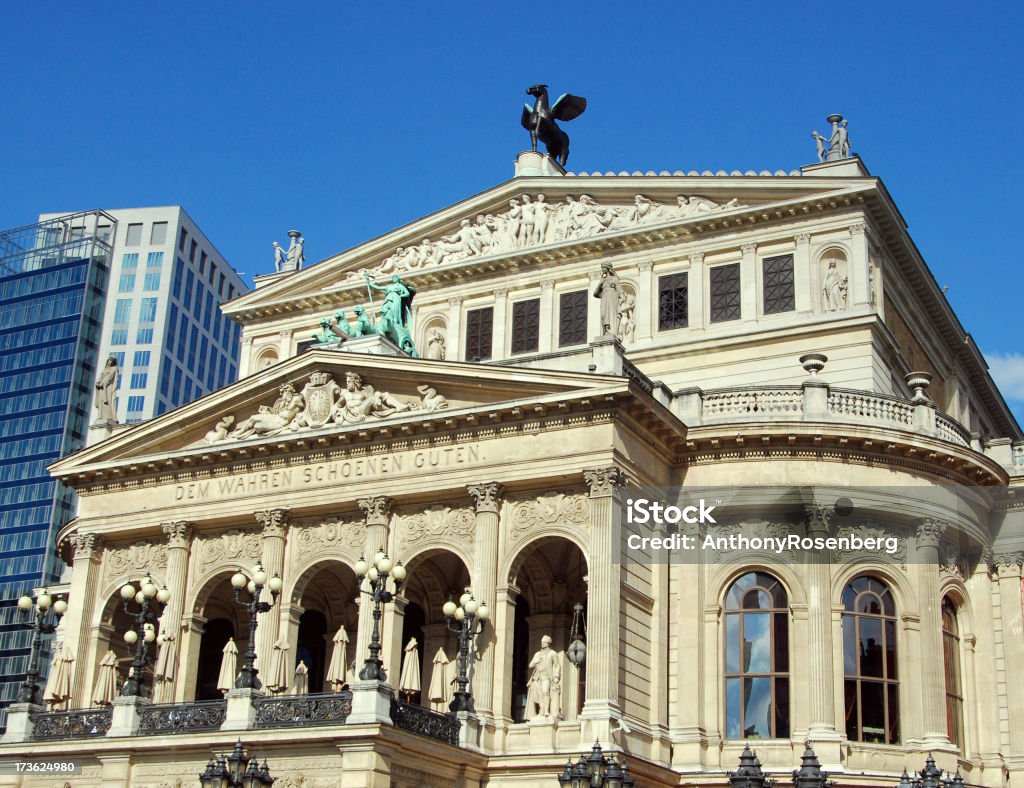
<box><xmin>915</xmin><ymin>518</ymin><xmax>954</xmax><ymax>748</ymax></box>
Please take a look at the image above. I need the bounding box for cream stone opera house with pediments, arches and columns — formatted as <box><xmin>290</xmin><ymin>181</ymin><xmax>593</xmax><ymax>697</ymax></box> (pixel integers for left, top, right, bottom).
<box><xmin>0</xmin><ymin>143</ymin><xmax>1024</xmax><ymax>788</ymax></box>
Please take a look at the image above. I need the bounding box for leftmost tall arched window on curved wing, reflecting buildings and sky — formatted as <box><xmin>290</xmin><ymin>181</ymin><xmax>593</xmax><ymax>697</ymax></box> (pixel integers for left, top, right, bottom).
<box><xmin>725</xmin><ymin>572</ymin><xmax>790</xmax><ymax>739</ymax></box>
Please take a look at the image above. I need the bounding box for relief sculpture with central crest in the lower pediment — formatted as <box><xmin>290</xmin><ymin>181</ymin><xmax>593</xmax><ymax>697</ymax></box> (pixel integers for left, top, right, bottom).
<box><xmin>203</xmin><ymin>371</ymin><xmax>449</xmax><ymax>444</ymax></box>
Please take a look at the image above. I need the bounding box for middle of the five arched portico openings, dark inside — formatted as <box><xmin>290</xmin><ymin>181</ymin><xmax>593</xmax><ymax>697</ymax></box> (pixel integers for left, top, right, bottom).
<box><xmin>289</xmin><ymin>561</ymin><xmax>358</xmax><ymax>692</ymax></box>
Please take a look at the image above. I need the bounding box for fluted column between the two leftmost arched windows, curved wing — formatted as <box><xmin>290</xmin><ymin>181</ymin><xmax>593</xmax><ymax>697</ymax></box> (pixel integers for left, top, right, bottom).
<box><xmin>792</xmin><ymin>506</ymin><xmax>840</xmax><ymax>745</ymax></box>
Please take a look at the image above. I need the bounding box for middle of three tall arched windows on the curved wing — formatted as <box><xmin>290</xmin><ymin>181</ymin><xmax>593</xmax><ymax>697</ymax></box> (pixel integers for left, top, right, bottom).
<box><xmin>843</xmin><ymin>577</ymin><xmax>899</xmax><ymax>744</ymax></box>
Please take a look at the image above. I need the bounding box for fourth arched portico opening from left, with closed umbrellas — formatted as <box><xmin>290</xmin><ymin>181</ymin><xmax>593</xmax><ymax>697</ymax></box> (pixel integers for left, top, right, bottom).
<box><xmin>401</xmin><ymin>550</ymin><xmax>473</xmax><ymax>711</ymax></box>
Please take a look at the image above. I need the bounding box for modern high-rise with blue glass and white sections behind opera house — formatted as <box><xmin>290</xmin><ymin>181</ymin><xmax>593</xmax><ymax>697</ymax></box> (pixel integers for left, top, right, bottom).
<box><xmin>0</xmin><ymin>206</ymin><xmax>248</xmax><ymax>726</ymax></box>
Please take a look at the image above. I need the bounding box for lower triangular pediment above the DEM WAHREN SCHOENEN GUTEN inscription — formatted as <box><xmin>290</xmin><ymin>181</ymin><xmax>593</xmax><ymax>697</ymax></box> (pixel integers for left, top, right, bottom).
<box><xmin>50</xmin><ymin>350</ymin><xmax>628</xmax><ymax>478</ymax></box>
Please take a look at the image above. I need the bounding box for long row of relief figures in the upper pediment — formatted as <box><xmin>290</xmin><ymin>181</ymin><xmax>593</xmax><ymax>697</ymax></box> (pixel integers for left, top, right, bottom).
<box><xmin>347</xmin><ymin>194</ymin><xmax>740</xmax><ymax>281</ymax></box>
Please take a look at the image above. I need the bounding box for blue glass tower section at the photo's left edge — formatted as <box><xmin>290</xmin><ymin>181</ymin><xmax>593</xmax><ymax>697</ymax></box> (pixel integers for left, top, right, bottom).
<box><xmin>0</xmin><ymin>211</ymin><xmax>117</xmax><ymax>726</ymax></box>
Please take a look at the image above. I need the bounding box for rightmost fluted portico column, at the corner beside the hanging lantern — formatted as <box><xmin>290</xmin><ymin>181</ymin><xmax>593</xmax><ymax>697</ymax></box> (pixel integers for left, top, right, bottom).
<box><xmin>581</xmin><ymin>466</ymin><xmax>626</xmax><ymax>738</ymax></box>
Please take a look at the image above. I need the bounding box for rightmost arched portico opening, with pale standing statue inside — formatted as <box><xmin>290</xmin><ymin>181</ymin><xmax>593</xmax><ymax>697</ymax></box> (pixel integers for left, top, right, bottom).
<box><xmin>506</xmin><ymin>536</ymin><xmax>587</xmax><ymax>723</ymax></box>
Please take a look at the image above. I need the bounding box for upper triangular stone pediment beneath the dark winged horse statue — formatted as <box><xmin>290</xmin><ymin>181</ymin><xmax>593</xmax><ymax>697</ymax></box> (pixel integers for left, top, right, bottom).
<box><xmin>223</xmin><ymin>173</ymin><xmax>876</xmax><ymax>320</ymax></box>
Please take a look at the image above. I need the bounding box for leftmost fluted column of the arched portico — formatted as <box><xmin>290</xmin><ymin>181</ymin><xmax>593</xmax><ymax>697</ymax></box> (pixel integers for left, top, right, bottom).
<box><xmin>62</xmin><ymin>532</ymin><xmax>102</xmax><ymax>708</ymax></box>
